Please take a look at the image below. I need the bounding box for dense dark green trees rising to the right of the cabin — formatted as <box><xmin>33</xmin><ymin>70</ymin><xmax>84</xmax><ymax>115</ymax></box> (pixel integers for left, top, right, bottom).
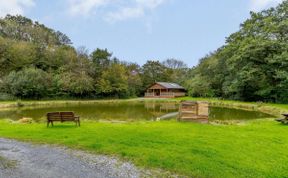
<box><xmin>186</xmin><ymin>0</ymin><xmax>288</xmax><ymax>102</ymax></box>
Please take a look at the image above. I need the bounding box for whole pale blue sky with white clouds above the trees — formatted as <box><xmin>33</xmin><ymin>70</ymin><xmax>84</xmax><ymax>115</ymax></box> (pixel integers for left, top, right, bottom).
<box><xmin>0</xmin><ymin>0</ymin><xmax>283</xmax><ymax>67</ymax></box>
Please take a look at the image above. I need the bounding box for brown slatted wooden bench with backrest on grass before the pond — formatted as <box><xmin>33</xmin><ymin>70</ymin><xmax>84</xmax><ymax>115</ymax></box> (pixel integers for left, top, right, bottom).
<box><xmin>47</xmin><ymin>112</ymin><xmax>80</xmax><ymax>127</ymax></box>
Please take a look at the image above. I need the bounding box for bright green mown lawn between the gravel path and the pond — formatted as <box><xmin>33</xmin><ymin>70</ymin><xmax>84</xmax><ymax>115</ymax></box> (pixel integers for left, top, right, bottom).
<box><xmin>0</xmin><ymin>119</ymin><xmax>288</xmax><ymax>177</ymax></box>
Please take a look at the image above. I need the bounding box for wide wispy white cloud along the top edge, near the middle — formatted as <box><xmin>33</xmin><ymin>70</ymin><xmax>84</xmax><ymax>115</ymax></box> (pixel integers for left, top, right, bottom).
<box><xmin>67</xmin><ymin>0</ymin><xmax>168</xmax><ymax>22</ymax></box>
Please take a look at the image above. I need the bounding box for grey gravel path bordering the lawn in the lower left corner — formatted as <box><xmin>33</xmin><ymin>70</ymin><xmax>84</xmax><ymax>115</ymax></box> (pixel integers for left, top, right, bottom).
<box><xmin>0</xmin><ymin>138</ymin><xmax>151</xmax><ymax>178</ymax></box>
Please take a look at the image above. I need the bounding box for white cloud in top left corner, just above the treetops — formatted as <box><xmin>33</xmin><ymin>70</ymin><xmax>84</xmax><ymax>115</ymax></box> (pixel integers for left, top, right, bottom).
<box><xmin>0</xmin><ymin>0</ymin><xmax>35</xmax><ymax>17</ymax></box>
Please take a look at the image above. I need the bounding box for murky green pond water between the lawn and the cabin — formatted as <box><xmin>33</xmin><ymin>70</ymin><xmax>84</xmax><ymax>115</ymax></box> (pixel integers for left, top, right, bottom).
<box><xmin>0</xmin><ymin>102</ymin><xmax>273</xmax><ymax>121</ymax></box>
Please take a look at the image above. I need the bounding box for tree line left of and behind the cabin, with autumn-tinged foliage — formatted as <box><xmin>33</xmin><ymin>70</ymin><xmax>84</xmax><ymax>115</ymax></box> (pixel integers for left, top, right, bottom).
<box><xmin>0</xmin><ymin>15</ymin><xmax>188</xmax><ymax>99</ymax></box>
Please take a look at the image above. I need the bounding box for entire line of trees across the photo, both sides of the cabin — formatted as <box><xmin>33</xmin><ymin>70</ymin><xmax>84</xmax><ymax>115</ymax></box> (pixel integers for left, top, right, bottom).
<box><xmin>0</xmin><ymin>0</ymin><xmax>288</xmax><ymax>103</ymax></box>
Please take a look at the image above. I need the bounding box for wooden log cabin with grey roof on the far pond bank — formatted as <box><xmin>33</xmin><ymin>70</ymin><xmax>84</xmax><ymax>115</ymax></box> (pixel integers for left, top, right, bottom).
<box><xmin>145</xmin><ymin>82</ymin><xmax>186</xmax><ymax>98</ymax></box>
